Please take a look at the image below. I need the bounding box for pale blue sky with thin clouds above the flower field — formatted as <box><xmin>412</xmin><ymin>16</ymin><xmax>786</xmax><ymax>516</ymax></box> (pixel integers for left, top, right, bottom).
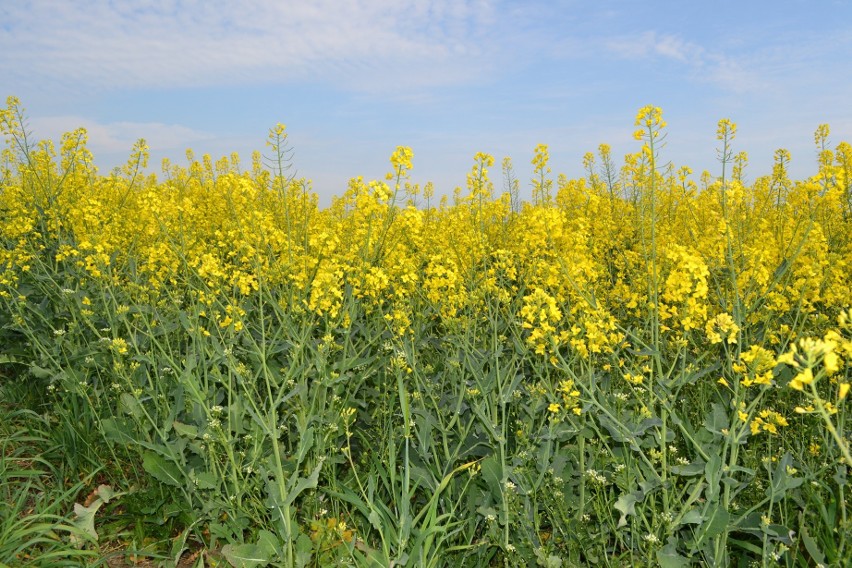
<box><xmin>0</xmin><ymin>0</ymin><xmax>852</xmax><ymax>205</ymax></box>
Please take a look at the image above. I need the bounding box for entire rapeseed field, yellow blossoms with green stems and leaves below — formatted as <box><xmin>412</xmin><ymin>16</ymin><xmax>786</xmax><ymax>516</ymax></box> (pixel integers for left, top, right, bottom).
<box><xmin>0</xmin><ymin>97</ymin><xmax>852</xmax><ymax>568</ymax></box>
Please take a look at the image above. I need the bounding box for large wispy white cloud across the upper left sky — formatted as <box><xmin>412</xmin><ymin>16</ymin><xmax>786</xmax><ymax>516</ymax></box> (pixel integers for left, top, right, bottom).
<box><xmin>0</xmin><ymin>0</ymin><xmax>502</xmax><ymax>89</ymax></box>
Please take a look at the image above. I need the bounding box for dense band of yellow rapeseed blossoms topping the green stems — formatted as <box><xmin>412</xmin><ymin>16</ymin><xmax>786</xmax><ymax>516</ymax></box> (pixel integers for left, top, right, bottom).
<box><xmin>0</xmin><ymin>95</ymin><xmax>852</xmax><ymax>380</ymax></box>
